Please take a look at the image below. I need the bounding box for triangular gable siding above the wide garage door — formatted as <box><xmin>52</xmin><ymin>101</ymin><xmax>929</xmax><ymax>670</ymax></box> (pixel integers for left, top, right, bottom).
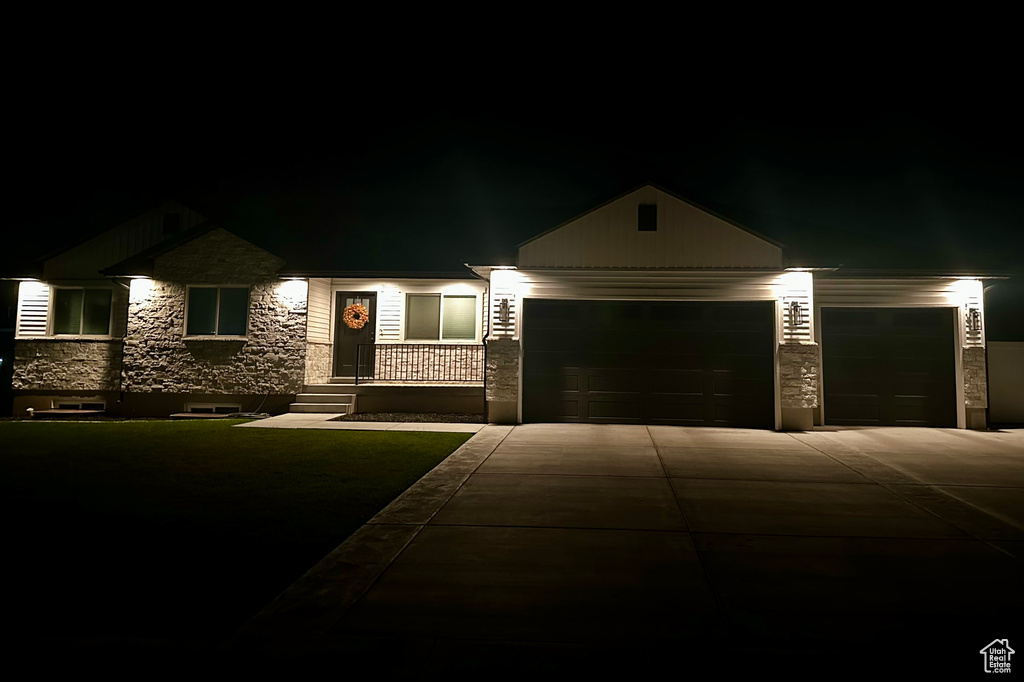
<box><xmin>518</xmin><ymin>185</ymin><xmax>782</xmax><ymax>268</ymax></box>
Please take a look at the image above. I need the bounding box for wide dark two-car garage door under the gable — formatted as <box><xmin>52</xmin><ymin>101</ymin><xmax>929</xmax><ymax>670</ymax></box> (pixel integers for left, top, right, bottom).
<box><xmin>522</xmin><ymin>299</ymin><xmax>775</xmax><ymax>428</ymax></box>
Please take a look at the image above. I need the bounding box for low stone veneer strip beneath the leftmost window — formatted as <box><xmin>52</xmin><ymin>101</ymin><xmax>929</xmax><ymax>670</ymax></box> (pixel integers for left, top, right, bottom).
<box><xmin>11</xmin><ymin>339</ymin><xmax>121</xmax><ymax>391</ymax></box>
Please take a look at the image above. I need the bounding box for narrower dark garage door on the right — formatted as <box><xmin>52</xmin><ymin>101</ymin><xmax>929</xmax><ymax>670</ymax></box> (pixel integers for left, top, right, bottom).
<box><xmin>821</xmin><ymin>308</ymin><xmax>956</xmax><ymax>427</ymax></box>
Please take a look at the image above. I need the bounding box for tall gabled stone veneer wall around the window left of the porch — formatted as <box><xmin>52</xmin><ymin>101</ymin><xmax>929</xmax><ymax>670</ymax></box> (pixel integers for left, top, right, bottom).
<box><xmin>124</xmin><ymin>229</ymin><xmax>306</xmax><ymax>394</ymax></box>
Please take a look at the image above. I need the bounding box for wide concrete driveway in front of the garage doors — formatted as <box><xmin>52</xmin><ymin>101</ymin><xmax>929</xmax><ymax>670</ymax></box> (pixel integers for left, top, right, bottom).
<box><xmin>232</xmin><ymin>424</ymin><xmax>1024</xmax><ymax>677</ymax></box>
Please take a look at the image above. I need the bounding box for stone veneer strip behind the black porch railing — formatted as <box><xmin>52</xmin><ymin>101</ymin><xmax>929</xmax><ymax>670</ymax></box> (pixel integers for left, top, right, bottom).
<box><xmin>374</xmin><ymin>344</ymin><xmax>483</xmax><ymax>381</ymax></box>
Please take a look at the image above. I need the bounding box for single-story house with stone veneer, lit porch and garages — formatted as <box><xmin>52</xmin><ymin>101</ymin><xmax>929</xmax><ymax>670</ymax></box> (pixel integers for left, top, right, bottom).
<box><xmin>13</xmin><ymin>184</ymin><xmax>987</xmax><ymax>429</ymax></box>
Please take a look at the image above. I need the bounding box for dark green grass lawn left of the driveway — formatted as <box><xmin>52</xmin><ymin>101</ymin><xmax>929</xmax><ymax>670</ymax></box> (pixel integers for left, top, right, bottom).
<box><xmin>0</xmin><ymin>420</ymin><xmax>469</xmax><ymax>641</ymax></box>
